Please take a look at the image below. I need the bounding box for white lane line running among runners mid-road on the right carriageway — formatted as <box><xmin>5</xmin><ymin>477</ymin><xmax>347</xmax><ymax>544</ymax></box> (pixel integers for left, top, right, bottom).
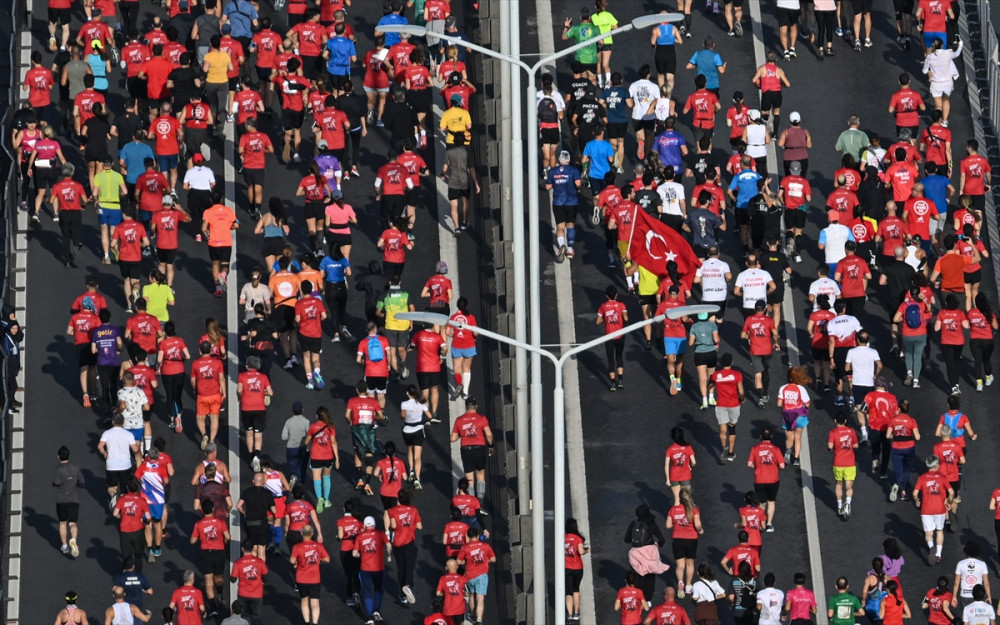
<box><xmin>750</xmin><ymin>0</ymin><xmax>828</xmax><ymax>625</ymax></box>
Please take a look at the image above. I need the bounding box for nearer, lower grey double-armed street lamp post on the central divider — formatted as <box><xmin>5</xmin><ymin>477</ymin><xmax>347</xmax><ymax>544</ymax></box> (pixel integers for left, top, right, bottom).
<box><xmin>396</xmin><ymin>304</ymin><xmax>719</xmax><ymax>625</ymax></box>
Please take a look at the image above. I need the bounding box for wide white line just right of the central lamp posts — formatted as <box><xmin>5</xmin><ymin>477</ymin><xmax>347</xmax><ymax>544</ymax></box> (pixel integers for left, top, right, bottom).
<box><xmin>526</xmin><ymin>0</ymin><xmax>597</xmax><ymax>623</ymax></box>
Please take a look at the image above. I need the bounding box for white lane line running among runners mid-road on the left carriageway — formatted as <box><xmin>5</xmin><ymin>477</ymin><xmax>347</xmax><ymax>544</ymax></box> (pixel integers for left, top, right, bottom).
<box><xmin>222</xmin><ymin>118</ymin><xmax>243</xmax><ymax>597</ymax></box>
